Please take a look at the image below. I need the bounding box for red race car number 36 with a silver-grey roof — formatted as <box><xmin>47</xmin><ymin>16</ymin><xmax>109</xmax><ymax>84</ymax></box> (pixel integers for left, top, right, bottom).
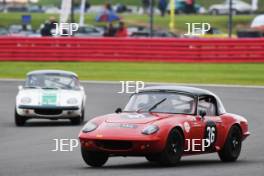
<box><xmin>79</xmin><ymin>86</ymin><xmax>250</xmax><ymax>167</ymax></box>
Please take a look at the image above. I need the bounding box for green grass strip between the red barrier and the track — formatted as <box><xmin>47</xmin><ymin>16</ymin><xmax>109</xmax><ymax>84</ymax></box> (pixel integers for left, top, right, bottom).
<box><xmin>0</xmin><ymin>62</ymin><xmax>264</xmax><ymax>85</ymax></box>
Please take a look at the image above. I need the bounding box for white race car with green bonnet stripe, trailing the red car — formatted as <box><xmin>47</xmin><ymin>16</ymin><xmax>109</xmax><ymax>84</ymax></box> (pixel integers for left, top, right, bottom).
<box><xmin>15</xmin><ymin>70</ymin><xmax>86</xmax><ymax>126</ymax></box>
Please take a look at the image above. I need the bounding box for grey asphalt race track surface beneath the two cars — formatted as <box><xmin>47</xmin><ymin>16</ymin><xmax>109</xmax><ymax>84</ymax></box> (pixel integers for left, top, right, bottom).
<box><xmin>0</xmin><ymin>81</ymin><xmax>264</xmax><ymax>176</ymax></box>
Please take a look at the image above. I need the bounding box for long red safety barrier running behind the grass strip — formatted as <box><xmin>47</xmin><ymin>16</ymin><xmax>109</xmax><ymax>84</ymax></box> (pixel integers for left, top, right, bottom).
<box><xmin>0</xmin><ymin>37</ymin><xmax>264</xmax><ymax>63</ymax></box>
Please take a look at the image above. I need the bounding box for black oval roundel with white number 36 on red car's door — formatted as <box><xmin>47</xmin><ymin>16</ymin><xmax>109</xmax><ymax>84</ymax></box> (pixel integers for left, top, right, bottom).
<box><xmin>204</xmin><ymin>121</ymin><xmax>217</xmax><ymax>150</ymax></box>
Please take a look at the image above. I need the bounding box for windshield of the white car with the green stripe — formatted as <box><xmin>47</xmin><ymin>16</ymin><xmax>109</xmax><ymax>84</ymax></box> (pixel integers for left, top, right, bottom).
<box><xmin>25</xmin><ymin>74</ymin><xmax>80</xmax><ymax>90</ymax></box>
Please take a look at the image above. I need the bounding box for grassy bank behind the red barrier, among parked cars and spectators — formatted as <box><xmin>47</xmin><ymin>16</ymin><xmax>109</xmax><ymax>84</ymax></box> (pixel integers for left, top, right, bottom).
<box><xmin>0</xmin><ymin>13</ymin><xmax>254</xmax><ymax>33</ymax></box>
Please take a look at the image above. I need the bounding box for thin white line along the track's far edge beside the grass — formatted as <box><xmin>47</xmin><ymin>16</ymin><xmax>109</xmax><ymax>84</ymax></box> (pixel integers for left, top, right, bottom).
<box><xmin>0</xmin><ymin>79</ymin><xmax>264</xmax><ymax>89</ymax></box>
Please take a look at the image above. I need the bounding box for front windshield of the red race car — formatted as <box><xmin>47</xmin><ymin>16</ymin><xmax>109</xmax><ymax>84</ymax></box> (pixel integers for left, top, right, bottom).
<box><xmin>124</xmin><ymin>92</ymin><xmax>195</xmax><ymax>114</ymax></box>
